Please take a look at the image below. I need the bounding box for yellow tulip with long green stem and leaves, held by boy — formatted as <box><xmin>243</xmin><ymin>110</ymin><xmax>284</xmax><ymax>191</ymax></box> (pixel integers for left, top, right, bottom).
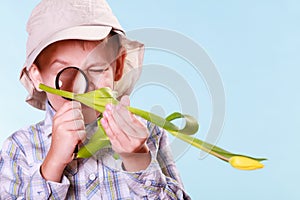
<box><xmin>39</xmin><ymin>84</ymin><xmax>266</xmax><ymax>170</ymax></box>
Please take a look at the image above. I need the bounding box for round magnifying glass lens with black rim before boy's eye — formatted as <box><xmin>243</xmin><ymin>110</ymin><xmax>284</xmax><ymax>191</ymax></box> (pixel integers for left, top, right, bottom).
<box><xmin>55</xmin><ymin>67</ymin><xmax>88</xmax><ymax>94</ymax></box>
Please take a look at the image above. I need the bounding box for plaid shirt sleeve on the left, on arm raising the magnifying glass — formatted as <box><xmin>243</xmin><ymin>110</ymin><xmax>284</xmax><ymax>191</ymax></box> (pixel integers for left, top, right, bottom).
<box><xmin>0</xmin><ymin>137</ymin><xmax>70</xmax><ymax>200</ymax></box>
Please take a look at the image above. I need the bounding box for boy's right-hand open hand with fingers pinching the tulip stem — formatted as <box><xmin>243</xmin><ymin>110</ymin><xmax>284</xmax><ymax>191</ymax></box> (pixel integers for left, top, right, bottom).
<box><xmin>101</xmin><ymin>96</ymin><xmax>151</xmax><ymax>171</ymax></box>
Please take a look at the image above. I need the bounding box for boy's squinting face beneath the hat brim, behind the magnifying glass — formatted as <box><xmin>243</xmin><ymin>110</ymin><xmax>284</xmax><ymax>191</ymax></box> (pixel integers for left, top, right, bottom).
<box><xmin>31</xmin><ymin>40</ymin><xmax>123</xmax><ymax>123</ymax></box>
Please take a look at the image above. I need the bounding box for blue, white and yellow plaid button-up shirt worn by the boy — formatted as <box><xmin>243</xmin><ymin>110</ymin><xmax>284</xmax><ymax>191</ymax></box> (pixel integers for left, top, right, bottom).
<box><xmin>0</xmin><ymin>106</ymin><xmax>190</xmax><ymax>200</ymax></box>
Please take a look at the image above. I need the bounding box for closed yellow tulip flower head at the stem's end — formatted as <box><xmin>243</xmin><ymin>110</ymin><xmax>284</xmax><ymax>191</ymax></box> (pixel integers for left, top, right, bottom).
<box><xmin>229</xmin><ymin>156</ymin><xmax>264</xmax><ymax>170</ymax></box>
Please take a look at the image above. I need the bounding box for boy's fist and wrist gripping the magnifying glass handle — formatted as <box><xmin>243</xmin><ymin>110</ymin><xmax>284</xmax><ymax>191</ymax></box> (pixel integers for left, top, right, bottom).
<box><xmin>41</xmin><ymin>101</ymin><xmax>86</xmax><ymax>182</ymax></box>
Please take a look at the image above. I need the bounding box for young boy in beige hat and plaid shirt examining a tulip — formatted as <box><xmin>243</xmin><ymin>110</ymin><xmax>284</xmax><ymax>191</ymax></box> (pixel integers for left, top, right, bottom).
<box><xmin>0</xmin><ymin>0</ymin><xmax>189</xmax><ymax>199</ymax></box>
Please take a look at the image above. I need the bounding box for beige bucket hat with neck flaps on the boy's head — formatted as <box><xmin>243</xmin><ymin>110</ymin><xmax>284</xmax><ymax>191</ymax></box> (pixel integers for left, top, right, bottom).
<box><xmin>20</xmin><ymin>0</ymin><xmax>144</xmax><ymax>110</ymax></box>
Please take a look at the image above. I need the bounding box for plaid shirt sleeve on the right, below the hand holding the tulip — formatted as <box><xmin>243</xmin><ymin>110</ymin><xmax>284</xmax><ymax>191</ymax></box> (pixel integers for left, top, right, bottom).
<box><xmin>123</xmin><ymin>126</ymin><xmax>190</xmax><ymax>199</ymax></box>
